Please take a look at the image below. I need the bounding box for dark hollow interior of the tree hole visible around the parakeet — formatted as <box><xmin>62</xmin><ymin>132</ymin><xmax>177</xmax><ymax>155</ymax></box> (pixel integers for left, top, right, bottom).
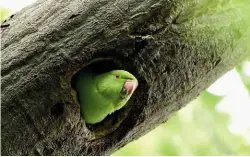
<box><xmin>71</xmin><ymin>58</ymin><xmax>135</xmax><ymax>138</ymax></box>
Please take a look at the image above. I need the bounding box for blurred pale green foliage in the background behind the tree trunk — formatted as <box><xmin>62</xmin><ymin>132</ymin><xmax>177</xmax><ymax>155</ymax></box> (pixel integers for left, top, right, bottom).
<box><xmin>1</xmin><ymin>3</ymin><xmax>250</xmax><ymax>155</ymax></box>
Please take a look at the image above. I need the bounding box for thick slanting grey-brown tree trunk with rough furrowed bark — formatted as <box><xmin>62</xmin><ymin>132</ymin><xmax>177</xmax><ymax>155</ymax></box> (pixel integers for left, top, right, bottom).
<box><xmin>1</xmin><ymin>0</ymin><xmax>249</xmax><ymax>155</ymax></box>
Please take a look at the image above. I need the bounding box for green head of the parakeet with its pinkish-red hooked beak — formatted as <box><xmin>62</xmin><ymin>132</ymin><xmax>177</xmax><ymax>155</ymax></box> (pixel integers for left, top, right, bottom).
<box><xmin>95</xmin><ymin>70</ymin><xmax>138</xmax><ymax>111</ymax></box>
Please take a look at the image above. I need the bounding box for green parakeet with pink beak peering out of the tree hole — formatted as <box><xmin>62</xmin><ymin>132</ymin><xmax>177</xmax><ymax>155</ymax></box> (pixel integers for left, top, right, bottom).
<box><xmin>76</xmin><ymin>70</ymin><xmax>138</xmax><ymax>124</ymax></box>
